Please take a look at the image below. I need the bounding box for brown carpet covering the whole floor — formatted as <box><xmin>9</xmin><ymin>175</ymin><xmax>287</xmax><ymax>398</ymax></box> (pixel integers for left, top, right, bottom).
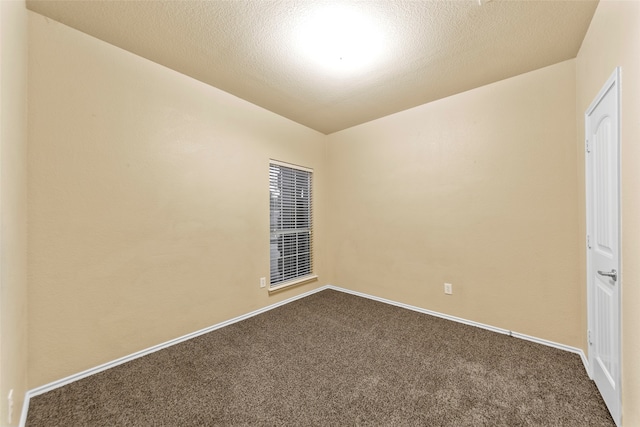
<box><xmin>27</xmin><ymin>290</ymin><xmax>614</xmax><ymax>427</ymax></box>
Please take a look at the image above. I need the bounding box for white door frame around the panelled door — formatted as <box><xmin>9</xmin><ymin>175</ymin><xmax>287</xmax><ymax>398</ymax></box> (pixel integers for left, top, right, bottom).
<box><xmin>584</xmin><ymin>67</ymin><xmax>623</xmax><ymax>426</ymax></box>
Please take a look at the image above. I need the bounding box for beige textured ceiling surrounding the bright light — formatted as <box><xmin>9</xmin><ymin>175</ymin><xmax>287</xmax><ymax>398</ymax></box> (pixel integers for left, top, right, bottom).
<box><xmin>27</xmin><ymin>0</ymin><xmax>597</xmax><ymax>134</ymax></box>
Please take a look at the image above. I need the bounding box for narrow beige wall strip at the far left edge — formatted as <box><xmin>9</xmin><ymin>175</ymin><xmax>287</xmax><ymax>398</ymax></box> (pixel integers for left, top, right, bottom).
<box><xmin>0</xmin><ymin>1</ymin><xmax>28</xmax><ymax>426</ymax></box>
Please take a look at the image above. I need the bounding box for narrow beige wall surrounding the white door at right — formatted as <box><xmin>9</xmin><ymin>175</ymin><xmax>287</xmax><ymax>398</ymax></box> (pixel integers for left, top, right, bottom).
<box><xmin>576</xmin><ymin>1</ymin><xmax>640</xmax><ymax>426</ymax></box>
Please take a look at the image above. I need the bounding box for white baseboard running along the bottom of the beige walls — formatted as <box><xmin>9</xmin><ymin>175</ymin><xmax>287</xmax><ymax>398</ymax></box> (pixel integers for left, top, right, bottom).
<box><xmin>19</xmin><ymin>285</ymin><xmax>589</xmax><ymax>427</ymax></box>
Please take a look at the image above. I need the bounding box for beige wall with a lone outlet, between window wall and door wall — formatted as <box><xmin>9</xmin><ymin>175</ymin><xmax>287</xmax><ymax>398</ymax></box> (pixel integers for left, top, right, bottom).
<box><xmin>329</xmin><ymin>60</ymin><xmax>584</xmax><ymax>346</ymax></box>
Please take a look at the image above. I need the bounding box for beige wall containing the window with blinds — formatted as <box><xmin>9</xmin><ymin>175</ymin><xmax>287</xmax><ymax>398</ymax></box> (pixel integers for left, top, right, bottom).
<box><xmin>28</xmin><ymin>12</ymin><xmax>327</xmax><ymax>387</ymax></box>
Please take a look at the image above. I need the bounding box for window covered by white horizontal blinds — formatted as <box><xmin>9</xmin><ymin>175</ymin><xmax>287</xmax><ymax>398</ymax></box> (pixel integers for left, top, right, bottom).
<box><xmin>269</xmin><ymin>160</ymin><xmax>313</xmax><ymax>288</ymax></box>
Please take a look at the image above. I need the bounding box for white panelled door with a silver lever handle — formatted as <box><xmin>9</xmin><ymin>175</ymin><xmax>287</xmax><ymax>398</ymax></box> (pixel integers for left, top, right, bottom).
<box><xmin>585</xmin><ymin>68</ymin><xmax>622</xmax><ymax>425</ymax></box>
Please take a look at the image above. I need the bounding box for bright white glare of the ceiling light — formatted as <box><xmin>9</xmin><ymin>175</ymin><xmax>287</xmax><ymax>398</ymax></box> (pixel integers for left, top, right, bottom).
<box><xmin>297</xmin><ymin>5</ymin><xmax>383</xmax><ymax>73</ymax></box>
